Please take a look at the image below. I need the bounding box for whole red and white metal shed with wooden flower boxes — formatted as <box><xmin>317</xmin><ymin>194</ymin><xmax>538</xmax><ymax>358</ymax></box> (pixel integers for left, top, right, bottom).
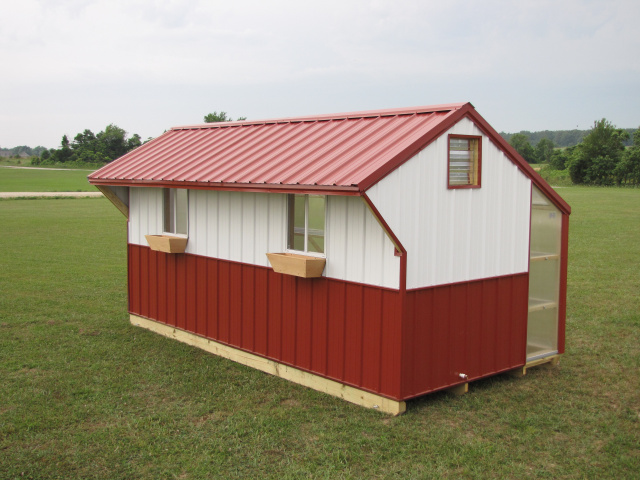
<box><xmin>89</xmin><ymin>103</ymin><xmax>570</xmax><ymax>414</ymax></box>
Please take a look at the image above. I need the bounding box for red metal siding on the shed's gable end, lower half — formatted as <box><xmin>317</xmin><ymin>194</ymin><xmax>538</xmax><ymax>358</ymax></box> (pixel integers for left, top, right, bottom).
<box><xmin>402</xmin><ymin>273</ymin><xmax>528</xmax><ymax>398</ymax></box>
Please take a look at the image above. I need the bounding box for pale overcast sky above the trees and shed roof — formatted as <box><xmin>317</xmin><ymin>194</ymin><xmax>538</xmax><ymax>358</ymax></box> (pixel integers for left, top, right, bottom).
<box><xmin>0</xmin><ymin>0</ymin><xmax>640</xmax><ymax>148</ymax></box>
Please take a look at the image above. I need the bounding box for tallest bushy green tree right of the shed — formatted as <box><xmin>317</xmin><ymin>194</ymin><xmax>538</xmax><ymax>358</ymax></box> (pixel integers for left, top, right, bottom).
<box><xmin>568</xmin><ymin>118</ymin><xmax>629</xmax><ymax>185</ymax></box>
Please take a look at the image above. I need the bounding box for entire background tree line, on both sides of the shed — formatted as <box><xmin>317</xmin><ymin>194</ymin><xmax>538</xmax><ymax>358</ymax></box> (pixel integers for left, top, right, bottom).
<box><xmin>7</xmin><ymin>111</ymin><xmax>640</xmax><ymax>185</ymax></box>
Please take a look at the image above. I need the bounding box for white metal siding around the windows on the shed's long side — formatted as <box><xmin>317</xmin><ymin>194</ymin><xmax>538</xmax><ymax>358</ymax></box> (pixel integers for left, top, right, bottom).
<box><xmin>129</xmin><ymin>188</ymin><xmax>400</xmax><ymax>288</ymax></box>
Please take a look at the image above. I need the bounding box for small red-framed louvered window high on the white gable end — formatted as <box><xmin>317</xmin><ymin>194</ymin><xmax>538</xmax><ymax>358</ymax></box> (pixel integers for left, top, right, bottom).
<box><xmin>449</xmin><ymin>135</ymin><xmax>482</xmax><ymax>188</ymax></box>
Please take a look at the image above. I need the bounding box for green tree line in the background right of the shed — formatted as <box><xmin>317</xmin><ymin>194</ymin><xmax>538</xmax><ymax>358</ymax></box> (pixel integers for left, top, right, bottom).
<box><xmin>509</xmin><ymin>118</ymin><xmax>640</xmax><ymax>185</ymax></box>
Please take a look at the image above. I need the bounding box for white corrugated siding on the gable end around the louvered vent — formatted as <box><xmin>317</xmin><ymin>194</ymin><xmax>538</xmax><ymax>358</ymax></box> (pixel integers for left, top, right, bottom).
<box><xmin>367</xmin><ymin>119</ymin><xmax>531</xmax><ymax>289</ymax></box>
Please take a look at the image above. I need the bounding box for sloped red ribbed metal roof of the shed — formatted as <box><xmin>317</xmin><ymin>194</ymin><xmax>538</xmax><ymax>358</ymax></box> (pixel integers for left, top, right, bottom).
<box><xmin>89</xmin><ymin>103</ymin><xmax>469</xmax><ymax>191</ymax></box>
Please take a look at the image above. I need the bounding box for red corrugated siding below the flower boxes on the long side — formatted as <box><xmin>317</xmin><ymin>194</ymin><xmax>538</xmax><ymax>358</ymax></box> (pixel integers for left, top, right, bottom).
<box><xmin>129</xmin><ymin>245</ymin><xmax>400</xmax><ymax>398</ymax></box>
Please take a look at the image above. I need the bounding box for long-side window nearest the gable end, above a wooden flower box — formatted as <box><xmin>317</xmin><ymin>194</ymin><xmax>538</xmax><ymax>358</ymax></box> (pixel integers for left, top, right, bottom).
<box><xmin>287</xmin><ymin>195</ymin><xmax>326</xmax><ymax>255</ymax></box>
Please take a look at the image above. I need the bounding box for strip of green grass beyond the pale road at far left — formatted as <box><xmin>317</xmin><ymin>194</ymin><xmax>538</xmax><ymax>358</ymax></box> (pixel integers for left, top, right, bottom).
<box><xmin>0</xmin><ymin>168</ymin><xmax>97</xmax><ymax>192</ymax></box>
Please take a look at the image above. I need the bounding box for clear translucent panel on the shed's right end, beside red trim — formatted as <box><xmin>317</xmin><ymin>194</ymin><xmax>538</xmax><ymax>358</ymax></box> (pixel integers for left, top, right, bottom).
<box><xmin>527</xmin><ymin>187</ymin><xmax>562</xmax><ymax>359</ymax></box>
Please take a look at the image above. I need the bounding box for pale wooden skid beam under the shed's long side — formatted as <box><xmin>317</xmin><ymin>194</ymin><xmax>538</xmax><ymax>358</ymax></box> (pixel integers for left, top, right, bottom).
<box><xmin>130</xmin><ymin>314</ymin><xmax>407</xmax><ymax>415</ymax></box>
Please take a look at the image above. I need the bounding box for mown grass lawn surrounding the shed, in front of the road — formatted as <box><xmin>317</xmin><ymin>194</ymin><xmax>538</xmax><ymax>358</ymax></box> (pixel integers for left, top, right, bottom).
<box><xmin>0</xmin><ymin>192</ymin><xmax>640</xmax><ymax>479</ymax></box>
